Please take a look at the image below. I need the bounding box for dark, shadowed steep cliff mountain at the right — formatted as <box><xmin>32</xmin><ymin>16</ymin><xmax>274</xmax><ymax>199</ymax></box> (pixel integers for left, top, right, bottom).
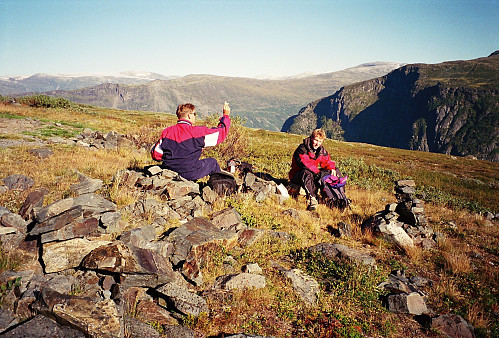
<box><xmin>283</xmin><ymin>52</ymin><xmax>499</xmax><ymax>161</ymax></box>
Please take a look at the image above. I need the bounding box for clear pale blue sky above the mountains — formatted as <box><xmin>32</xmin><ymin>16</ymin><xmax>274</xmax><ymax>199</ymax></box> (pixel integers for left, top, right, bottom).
<box><xmin>0</xmin><ymin>0</ymin><xmax>499</xmax><ymax>77</ymax></box>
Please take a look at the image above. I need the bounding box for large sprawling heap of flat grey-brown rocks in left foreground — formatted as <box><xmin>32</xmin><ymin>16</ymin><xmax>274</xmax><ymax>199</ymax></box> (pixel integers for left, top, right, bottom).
<box><xmin>0</xmin><ymin>166</ymin><xmax>332</xmax><ymax>337</ymax></box>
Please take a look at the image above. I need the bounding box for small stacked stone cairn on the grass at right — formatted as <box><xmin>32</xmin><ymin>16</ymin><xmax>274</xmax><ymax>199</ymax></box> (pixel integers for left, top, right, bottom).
<box><xmin>362</xmin><ymin>180</ymin><xmax>436</xmax><ymax>249</ymax></box>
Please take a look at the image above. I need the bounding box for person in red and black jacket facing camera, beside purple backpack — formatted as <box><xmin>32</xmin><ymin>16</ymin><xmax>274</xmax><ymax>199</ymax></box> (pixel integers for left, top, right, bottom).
<box><xmin>289</xmin><ymin>129</ymin><xmax>336</xmax><ymax>210</ymax></box>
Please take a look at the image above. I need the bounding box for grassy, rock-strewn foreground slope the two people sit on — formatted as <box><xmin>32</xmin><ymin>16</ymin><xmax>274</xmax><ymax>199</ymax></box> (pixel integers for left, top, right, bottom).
<box><xmin>0</xmin><ymin>99</ymin><xmax>499</xmax><ymax>338</ymax></box>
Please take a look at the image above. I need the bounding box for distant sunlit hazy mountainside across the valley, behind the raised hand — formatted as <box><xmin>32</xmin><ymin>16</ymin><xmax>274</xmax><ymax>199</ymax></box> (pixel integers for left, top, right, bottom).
<box><xmin>10</xmin><ymin>62</ymin><xmax>400</xmax><ymax>131</ymax></box>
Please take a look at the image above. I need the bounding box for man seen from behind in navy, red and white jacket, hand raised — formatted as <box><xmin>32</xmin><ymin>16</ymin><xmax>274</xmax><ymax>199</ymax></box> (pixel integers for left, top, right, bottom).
<box><xmin>153</xmin><ymin>102</ymin><xmax>230</xmax><ymax>180</ymax></box>
